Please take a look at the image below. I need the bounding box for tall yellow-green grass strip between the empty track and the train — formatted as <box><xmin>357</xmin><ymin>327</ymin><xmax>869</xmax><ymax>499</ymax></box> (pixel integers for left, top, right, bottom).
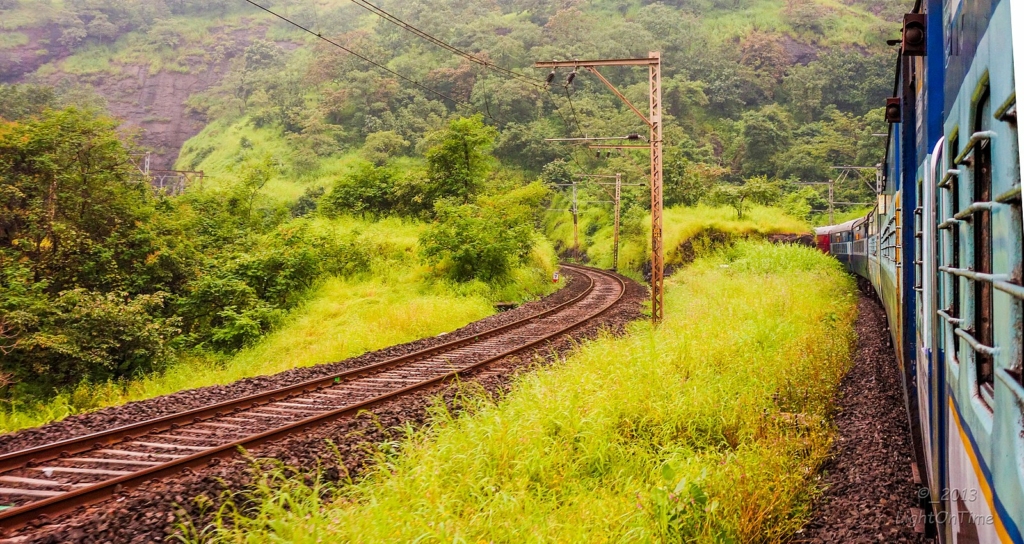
<box><xmin>185</xmin><ymin>242</ymin><xmax>855</xmax><ymax>543</ymax></box>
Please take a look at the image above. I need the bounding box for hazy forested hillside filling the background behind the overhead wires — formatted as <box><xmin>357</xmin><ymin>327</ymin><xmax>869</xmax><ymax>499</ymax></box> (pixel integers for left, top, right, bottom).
<box><xmin>0</xmin><ymin>0</ymin><xmax>907</xmax><ymax>192</ymax></box>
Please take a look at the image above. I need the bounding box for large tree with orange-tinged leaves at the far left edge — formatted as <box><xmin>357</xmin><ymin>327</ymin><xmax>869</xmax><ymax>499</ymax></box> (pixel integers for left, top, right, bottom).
<box><xmin>0</xmin><ymin>109</ymin><xmax>151</xmax><ymax>292</ymax></box>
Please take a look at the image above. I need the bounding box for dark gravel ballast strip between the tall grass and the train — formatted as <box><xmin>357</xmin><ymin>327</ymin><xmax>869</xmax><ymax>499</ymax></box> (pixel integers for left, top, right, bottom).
<box><xmin>793</xmin><ymin>286</ymin><xmax>929</xmax><ymax>544</ymax></box>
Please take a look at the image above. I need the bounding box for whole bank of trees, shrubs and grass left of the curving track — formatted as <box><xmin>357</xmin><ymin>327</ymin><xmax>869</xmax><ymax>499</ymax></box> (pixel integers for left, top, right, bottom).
<box><xmin>0</xmin><ymin>95</ymin><xmax>554</xmax><ymax>429</ymax></box>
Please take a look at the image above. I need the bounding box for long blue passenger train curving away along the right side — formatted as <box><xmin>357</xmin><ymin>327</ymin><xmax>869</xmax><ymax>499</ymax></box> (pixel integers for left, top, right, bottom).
<box><xmin>815</xmin><ymin>0</ymin><xmax>1024</xmax><ymax>544</ymax></box>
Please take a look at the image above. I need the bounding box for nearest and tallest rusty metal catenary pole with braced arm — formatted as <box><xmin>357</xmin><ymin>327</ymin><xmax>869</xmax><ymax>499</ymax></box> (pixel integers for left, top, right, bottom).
<box><xmin>534</xmin><ymin>51</ymin><xmax>665</xmax><ymax>324</ymax></box>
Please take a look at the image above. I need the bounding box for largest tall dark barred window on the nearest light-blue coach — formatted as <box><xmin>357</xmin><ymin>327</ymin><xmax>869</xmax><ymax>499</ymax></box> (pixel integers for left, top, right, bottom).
<box><xmin>972</xmin><ymin>93</ymin><xmax>994</xmax><ymax>386</ymax></box>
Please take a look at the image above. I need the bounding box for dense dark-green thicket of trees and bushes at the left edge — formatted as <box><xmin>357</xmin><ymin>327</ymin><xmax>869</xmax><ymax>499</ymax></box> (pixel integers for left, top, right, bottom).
<box><xmin>0</xmin><ymin>107</ymin><xmax>387</xmax><ymax>393</ymax></box>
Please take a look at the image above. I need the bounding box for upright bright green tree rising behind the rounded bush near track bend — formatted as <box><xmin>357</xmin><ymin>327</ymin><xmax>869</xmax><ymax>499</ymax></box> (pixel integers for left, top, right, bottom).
<box><xmin>426</xmin><ymin>115</ymin><xmax>498</xmax><ymax>204</ymax></box>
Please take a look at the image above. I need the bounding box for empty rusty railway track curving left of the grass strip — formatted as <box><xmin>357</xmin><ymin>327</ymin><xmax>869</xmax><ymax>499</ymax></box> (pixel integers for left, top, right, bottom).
<box><xmin>0</xmin><ymin>265</ymin><xmax>626</xmax><ymax>533</ymax></box>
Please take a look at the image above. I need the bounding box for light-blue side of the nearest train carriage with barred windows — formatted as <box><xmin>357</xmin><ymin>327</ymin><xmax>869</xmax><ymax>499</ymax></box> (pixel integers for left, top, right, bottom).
<box><xmin>937</xmin><ymin>0</ymin><xmax>1024</xmax><ymax>542</ymax></box>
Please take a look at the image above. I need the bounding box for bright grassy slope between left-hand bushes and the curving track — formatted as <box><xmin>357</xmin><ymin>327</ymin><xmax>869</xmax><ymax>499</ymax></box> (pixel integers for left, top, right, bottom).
<box><xmin>0</xmin><ymin>218</ymin><xmax>555</xmax><ymax>432</ymax></box>
